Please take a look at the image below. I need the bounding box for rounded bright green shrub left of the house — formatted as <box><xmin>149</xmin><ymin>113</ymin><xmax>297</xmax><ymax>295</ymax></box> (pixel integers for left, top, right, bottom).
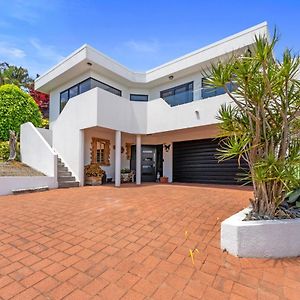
<box><xmin>0</xmin><ymin>84</ymin><xmax>42</xmax><ymax>141</ymax></box>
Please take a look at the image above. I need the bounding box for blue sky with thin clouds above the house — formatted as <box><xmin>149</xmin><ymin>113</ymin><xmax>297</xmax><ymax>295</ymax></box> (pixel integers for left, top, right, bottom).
<box><xmin>0</xmin><ymin>0</ymin><xmax>300</xmax><ymax>76</ymax></box>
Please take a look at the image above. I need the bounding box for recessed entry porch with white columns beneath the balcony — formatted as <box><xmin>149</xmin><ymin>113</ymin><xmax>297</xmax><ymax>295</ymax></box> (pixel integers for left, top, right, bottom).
<box><xmin>82</xmin><ymin>126</ymin><xmax>217</xmax><ymax>186</ymax></box>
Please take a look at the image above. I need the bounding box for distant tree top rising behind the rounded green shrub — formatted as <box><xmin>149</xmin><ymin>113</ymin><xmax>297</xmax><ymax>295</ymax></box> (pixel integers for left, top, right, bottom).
<box><xmin>0</xmin><ymin>62</ymin><xmax>33</xmax><ymax>89</ymax></box>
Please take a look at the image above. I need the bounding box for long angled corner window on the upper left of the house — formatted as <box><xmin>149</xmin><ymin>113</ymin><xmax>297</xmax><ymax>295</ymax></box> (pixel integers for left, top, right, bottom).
<box><xmin>60</xmin><ymin>78</ymin><xmax>122</xmax><ymax>111</ymax></box>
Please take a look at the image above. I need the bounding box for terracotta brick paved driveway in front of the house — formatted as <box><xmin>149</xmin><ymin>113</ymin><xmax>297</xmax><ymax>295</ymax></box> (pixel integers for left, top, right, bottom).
<box><xmin>0</xmin><ymin>185</ymin><xmax>300</xmax><ymax>300</ymax></box>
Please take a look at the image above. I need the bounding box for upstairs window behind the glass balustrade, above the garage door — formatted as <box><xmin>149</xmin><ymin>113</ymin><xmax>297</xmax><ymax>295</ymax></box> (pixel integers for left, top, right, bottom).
<box><xmin>160</xmin><ymin>82</ymin><xmax>194</xmax><ymax>106</ymax></box>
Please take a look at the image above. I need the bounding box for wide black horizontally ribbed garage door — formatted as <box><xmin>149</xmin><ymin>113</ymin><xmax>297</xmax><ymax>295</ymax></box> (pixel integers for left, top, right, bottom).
<box><xmin>173</xmin><ymin>139</ymin><xmax>247</xmax><ymax>184</ymax></box>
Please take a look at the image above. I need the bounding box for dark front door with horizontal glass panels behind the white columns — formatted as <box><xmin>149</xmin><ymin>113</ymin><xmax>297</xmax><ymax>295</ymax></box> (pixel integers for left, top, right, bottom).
<box><xmin>142</xmin><ymin>146</ymin><xmax>156</xmax><ymax>182</ymax></box>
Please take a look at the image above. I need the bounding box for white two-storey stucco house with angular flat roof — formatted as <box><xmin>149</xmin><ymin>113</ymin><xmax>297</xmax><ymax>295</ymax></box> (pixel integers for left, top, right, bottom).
<box><xmin>21</xmin><ymin>22</ymin><xmax>267</xmax><ymax>186</ymax></box>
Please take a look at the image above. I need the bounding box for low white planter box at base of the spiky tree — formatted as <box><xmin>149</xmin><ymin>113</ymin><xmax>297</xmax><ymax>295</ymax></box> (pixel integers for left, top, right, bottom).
<box><xmin>221</xmin><ymin>208</ymin><xmax>300</xmax><ymax>258</ymax></box>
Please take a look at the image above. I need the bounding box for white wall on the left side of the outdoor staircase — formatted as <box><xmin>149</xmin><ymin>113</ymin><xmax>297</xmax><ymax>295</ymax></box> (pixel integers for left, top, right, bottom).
<box><xmin>20</xmin><ymin>122</ymin><xmax>57</xmax><ymax>178</ymax></box>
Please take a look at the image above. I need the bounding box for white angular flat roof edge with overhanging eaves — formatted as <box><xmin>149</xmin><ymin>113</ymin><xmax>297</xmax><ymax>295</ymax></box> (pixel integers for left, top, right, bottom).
<box><xmin>35</xmin><ymin>22</ymin><xmax>268</xmax><ymax>92</ymax></box>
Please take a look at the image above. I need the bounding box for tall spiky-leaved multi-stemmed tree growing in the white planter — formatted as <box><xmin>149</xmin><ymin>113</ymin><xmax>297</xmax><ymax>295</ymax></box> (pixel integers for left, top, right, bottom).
<box><xmin>207</xmin><ymin>33</ymin><xmax>300</xmax><ymax>219</ymax></box>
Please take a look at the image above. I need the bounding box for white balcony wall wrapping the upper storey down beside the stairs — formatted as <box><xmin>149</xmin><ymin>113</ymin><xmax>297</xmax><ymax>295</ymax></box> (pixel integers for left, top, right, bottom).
<box><xmin>52</xmin><ymin>88</ymin><xmax>225</xmax><ymax>183</ymax></box>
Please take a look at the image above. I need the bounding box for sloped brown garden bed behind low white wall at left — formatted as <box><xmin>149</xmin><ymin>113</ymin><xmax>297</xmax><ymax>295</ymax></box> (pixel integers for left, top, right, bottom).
<box><xmin>0</xmin><ymin>161</ymin><xmax>44</xmax><ymax>176</ymax></box>
